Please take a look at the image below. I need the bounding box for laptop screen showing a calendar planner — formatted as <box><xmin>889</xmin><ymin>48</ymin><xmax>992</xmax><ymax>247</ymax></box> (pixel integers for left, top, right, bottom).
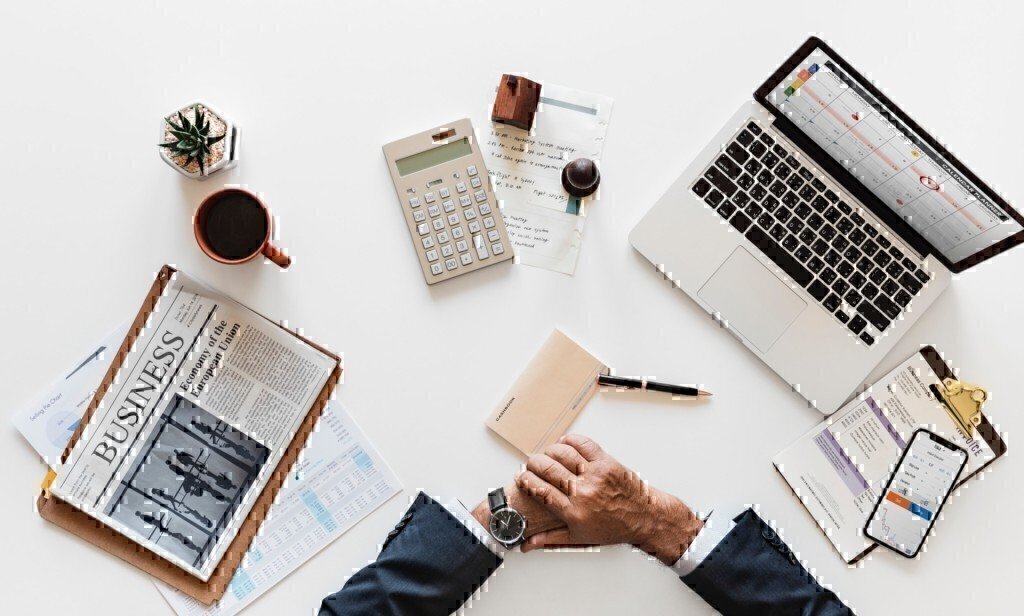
<box><xmin>765</xmin><ymin>40</ymin><xmax>1024</xmax><ymax>263</ymax></box>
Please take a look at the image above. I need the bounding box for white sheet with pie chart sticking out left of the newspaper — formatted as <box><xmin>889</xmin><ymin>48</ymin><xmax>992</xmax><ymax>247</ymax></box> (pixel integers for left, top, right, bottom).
<box><xmin>13</xmin><ymin>323</ymin><xmax>131</xmax><ymax>469</ymax></box>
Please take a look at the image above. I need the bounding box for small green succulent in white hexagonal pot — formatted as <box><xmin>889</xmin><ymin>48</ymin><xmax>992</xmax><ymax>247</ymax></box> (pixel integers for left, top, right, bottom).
<box><xmin>159</xmin><ymin>102</ymin><xmax>239</xmax><ymax>180</ymax></box>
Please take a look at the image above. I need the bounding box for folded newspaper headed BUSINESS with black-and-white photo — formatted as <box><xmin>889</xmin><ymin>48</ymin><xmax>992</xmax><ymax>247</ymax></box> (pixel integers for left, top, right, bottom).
<box><xmin>50</xmin><ymin>272</ymin><xmax>336</xmax><ymax>581</ymax></box>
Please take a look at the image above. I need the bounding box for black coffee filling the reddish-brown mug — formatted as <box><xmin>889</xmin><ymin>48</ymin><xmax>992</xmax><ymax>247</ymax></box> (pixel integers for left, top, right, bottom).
<box><xmin>199</xmin><ymin>190</ymin><xmax>267</xmax><ymax>261</ymax></box>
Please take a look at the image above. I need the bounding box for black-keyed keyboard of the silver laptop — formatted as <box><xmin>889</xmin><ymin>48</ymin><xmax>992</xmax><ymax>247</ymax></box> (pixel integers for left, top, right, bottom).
<box><xmin>690</xmin><ymin>122</ymin><xmax>930</xmax><ymax>346</ymax></box>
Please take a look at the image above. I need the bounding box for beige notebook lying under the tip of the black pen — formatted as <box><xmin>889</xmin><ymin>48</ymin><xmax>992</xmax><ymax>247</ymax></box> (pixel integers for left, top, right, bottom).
<box><xmin>486</xmin><ymin>329</ymin><xmax>608</xmax><ymax>455</ymax></box>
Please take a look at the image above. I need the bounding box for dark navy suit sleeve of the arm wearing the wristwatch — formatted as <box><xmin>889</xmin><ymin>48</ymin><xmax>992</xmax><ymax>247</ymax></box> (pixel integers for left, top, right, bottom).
<box><xmin>319</xmin><ymin>492</ymin><xmax>502</xmax><ymax>616</ymax></box>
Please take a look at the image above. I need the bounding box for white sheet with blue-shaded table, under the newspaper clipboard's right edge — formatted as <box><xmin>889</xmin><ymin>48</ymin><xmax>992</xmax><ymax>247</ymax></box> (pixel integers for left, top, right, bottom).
<box><xmin>155</xmin><ymin>401</ymin><xmax>401</xmax><ymax>616</ymax></box>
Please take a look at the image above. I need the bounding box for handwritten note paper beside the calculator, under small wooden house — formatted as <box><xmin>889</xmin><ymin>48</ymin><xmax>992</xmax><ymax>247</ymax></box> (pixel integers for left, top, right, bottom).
<box><xmin>480</xmin><ymin>84</ymin><xmax>612</xmax><ymax>275</ymax></box>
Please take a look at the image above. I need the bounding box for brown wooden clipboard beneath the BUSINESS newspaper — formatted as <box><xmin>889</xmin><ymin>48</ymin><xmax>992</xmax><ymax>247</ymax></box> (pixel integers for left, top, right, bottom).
<box><xmin>36</xmin><ymin>265</ymin><xmax>342</xmax><ymax>605</ymax></box>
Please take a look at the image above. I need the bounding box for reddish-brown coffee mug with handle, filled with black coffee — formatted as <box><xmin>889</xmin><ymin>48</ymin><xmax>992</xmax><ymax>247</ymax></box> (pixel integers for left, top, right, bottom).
<box><xmin>193</xmin><ymin>184</ymin><xmax>292</xmax><ymax>268</ymax></box>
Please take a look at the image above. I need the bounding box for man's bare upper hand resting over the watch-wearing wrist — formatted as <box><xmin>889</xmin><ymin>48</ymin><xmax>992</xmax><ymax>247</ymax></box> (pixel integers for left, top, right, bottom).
<box><xmin>516</xmin><ymin>435</ymin><xmax>702</xmax><ymax>565</ymax></box>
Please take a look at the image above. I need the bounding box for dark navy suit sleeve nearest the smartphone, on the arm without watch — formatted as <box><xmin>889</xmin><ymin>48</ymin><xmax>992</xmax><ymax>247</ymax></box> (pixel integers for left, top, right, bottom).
<box><xmin>681</xmin><ymin>510</ymin><xmax>853</xmax><ymax>616</ymax></box>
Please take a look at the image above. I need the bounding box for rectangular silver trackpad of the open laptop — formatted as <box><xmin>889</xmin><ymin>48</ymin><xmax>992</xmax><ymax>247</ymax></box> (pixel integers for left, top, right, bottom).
<box><xmin>697</xmin><ymin>247</ymin><xmax>807</xmax><ymax>352</ymax></box>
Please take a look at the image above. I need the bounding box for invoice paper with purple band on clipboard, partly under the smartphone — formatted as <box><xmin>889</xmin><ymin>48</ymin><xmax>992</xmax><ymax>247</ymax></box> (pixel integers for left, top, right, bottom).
<box><xmin>773</xmin><ymin>353</ymin><xmax>995</xmax><ymax>563</ymax></box>
